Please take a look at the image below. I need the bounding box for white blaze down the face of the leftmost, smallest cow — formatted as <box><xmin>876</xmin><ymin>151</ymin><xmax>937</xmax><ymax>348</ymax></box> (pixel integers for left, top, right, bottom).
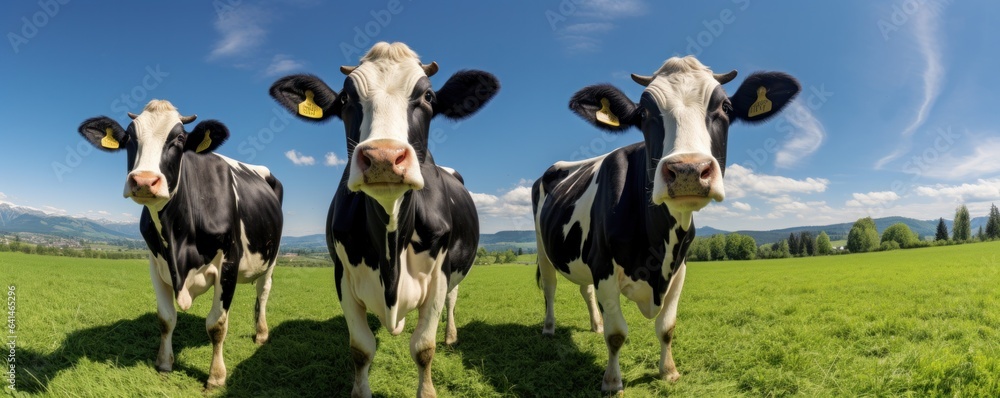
<box><xmin>124</xmin><ymin>99</ymin><xmax>181</xmax><ymax>200</ymax></box>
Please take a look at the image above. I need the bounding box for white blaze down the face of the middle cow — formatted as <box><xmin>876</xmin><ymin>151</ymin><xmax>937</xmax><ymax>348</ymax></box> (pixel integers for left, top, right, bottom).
<box><xmin>347</xmin><ymin>43</ymin><xmax>427</xmax><ymax>196</ymax></box>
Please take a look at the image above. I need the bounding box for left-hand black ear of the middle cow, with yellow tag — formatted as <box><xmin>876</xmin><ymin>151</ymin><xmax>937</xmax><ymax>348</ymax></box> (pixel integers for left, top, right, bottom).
<box><xmin>270</xmin><ymin>75</ymin><xmax>340</xmax><ymax>122</ymax></box>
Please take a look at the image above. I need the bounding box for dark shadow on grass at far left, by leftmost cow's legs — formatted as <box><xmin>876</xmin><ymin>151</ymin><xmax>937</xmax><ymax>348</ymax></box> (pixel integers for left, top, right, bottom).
<box><xmin>17</xmin><ymin>312</ymin><xmax>210</xmax><ymax>393</ymax></box>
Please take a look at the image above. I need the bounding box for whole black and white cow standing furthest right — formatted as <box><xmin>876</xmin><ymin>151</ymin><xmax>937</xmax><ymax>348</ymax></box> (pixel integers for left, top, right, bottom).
<box><xmin>532</xmin><ymin>57</ymin><xmax>800</xmax><ymax>391</ymax></box>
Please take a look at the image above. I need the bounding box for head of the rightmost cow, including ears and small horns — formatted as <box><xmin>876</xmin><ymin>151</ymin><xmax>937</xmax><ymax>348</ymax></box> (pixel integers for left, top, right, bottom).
<box><xmin>569</xmin><ymin>56</ymin><xmax>800</xmax><ymax>211</ymax></box>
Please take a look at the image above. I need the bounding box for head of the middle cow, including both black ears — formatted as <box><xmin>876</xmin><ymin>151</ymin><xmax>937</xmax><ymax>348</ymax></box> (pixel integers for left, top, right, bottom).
<box><xmin>270</xmin><ymin>42</ymin><xmax>500</xmax><ymax>210</ymax></box>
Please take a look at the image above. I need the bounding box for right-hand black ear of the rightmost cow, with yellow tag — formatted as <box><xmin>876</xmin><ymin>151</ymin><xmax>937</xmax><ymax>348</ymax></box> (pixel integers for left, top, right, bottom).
<box><xmin>729</xmin><ymin>72</ymin><xmax>802</xmax><ymax>123</ymax></box>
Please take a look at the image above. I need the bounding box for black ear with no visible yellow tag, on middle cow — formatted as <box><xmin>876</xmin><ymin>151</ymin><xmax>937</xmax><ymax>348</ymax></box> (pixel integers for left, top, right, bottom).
<box><xmin>434</xmin><ymin>70</ymin><xmax>500</xmax><ymax>120</ymax></box>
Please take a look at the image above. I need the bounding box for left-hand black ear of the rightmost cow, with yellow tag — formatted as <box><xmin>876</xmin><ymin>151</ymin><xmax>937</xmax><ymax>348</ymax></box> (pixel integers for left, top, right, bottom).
<box><xmin>569</xmin><ymin>84</ymin><xmax>639</xmax><ymax>133</ymax></box>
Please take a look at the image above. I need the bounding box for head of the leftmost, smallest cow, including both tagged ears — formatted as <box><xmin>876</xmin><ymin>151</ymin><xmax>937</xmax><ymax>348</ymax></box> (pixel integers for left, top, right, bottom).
<box><xmin>79</xmin><ymin>100</ymin><xmax>229</xmax><ymax>209</ymax></box>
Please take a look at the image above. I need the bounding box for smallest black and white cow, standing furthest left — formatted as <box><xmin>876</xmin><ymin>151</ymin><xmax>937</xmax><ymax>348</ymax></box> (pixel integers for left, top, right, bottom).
<box><xmin>79</xmin><ymin>100</ymin><xmax>282</xmax><ymax>388</ymax></box>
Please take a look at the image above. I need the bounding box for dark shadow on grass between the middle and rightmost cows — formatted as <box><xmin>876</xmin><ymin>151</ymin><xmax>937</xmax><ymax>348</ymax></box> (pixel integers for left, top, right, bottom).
<box><xmin>450</xmin><ymin>321</ymin><xmax>604</xmax><ymax>397</ymax></box>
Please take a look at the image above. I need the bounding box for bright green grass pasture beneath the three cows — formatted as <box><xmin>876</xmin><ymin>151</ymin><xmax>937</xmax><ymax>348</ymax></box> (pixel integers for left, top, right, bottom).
<box><xmin>0</xmin><ymin>242</ymin><xmax>1000</xmax><ymax>397</ymax></box>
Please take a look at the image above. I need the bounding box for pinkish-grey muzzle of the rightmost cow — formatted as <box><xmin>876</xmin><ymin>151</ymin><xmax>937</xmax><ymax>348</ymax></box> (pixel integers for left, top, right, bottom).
<box><xmin>653</xmin><ymin>155</ymin><xmax>725</xmax><ymax>211</ymax></box>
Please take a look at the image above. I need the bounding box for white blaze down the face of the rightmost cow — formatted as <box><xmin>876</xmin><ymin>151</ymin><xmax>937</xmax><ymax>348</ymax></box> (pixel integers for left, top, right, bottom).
<box><xmin>645</xmin><ymin>57</ymin><xmax>725</xmax><ymax>210</ymax></box>
